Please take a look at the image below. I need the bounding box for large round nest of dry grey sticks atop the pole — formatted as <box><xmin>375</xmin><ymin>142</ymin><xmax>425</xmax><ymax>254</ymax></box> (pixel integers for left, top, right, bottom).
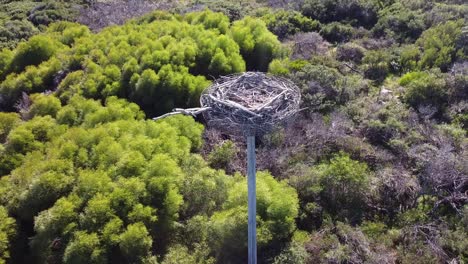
<box><xmin>200</xmin><ymin>72</ymin><xmax>301</xmax><ymax>135</ymax></box>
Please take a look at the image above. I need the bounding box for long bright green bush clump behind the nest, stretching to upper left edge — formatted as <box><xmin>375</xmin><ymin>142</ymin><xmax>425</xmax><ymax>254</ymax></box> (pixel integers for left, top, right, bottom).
<box><xmin>0</xmin><ymin>10</ymin><xmax>279</xmax><ymax>115</ymax></box>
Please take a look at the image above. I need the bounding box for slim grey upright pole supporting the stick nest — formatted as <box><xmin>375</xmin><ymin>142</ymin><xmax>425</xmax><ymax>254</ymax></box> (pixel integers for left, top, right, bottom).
<box><xmin>247</xmin><ymin>136</ymin><xmax>257</xmax><ymax>264</ymax></box>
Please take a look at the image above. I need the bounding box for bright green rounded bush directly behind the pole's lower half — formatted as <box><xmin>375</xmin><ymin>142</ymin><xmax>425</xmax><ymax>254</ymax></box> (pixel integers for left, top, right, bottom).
<box><xmin>210</xmin><ymin>172</ymin><xmax>298</xmax><ymax>262</ymax></box>
